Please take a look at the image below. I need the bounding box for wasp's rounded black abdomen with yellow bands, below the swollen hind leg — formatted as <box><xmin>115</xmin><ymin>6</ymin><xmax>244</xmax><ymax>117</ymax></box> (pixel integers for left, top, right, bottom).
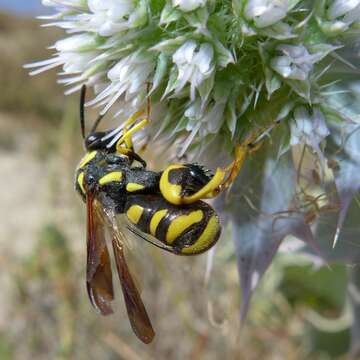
<box><xmin>125</xmin><ymin>195</ymin><xmax>221</xmax><ymax>255</ymax></box>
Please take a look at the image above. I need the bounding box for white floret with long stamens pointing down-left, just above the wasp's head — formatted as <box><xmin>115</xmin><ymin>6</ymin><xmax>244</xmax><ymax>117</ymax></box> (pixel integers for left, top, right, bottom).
<box><xmin>88</xmin><ymin>51</ymin><xmax>155</xmax><ymax>114</ymax></box>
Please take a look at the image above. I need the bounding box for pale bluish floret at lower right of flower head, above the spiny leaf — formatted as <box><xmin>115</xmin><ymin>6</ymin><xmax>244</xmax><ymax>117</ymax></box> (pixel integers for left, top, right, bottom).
<box><xmin>290</xmin><ymin>106</ymin><xmax>330</xmax><ymax>150</ymax></box>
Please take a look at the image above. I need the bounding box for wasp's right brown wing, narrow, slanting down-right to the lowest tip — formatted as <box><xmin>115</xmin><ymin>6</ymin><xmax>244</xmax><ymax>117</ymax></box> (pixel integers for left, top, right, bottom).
<box><xmin>104</xmin><ymin>214</ymin><xmax>155</xmax><ymax>344</ymax></box>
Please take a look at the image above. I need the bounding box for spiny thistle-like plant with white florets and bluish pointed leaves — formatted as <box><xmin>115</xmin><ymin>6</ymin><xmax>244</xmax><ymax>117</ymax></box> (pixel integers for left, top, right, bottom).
<box><xmin>28</xmin><ymin>0</ymin><xmax>360</xmax><ymax>348</ymax></box>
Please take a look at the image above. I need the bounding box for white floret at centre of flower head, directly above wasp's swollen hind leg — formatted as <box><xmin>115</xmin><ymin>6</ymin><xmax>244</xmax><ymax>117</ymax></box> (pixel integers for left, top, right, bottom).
<box><xmin>172</xmin><ymin>40</ymin><xmax>214</xmax><ymax>100</ymax></box>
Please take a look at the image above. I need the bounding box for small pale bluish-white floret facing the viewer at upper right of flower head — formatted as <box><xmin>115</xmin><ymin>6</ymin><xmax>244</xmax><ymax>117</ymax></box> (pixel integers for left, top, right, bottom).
<box><xmin>271</xmin><ymin>45</ymin><xmax>323</xmax><ymax>80</ymax></box>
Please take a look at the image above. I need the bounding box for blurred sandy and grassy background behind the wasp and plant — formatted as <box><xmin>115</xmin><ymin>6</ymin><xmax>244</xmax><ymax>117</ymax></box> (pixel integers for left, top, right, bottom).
<box><xmin>0</xmin><ymin>0</ymin><xmax>350</xmax><ymax>360</ymax></box>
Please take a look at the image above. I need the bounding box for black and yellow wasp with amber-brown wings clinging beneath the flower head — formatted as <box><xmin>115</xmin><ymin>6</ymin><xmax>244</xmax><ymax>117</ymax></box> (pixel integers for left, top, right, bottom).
<box><xmin>75</xmin><ymin>87</ymin><xmax>233</xmax><ymax>343</ymax></box>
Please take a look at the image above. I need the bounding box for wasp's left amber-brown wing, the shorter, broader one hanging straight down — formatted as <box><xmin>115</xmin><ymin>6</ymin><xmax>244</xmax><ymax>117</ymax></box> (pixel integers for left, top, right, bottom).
<box><xmin>86</xmin><ymin>193</ymin><xmax>114</xmax><ymax>315</ymax></box>
